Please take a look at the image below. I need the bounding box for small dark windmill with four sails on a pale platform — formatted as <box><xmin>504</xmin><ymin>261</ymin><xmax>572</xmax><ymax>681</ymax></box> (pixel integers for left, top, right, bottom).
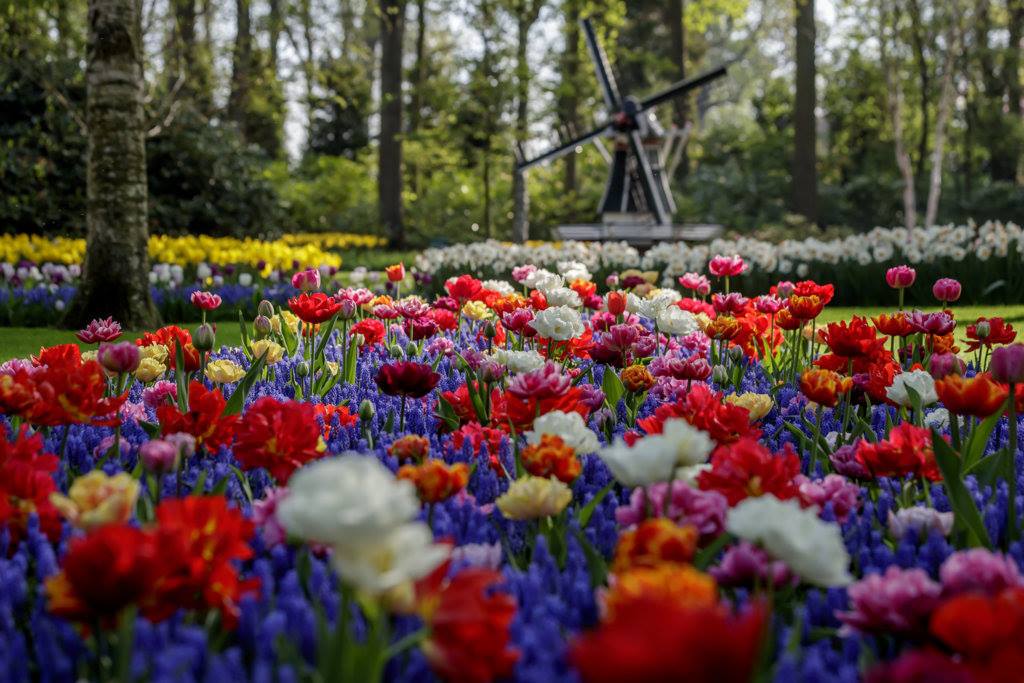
<box><xmin>516</xmin><ymin>18</ymin><xmax>726</xmax><ymax>242</ymax></box>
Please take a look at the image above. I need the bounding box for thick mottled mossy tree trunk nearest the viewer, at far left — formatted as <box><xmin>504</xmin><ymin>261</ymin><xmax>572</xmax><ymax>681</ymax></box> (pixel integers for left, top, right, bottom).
<box><xmin>63</xmin><ymin>0</ymin><xmax>160</xmax><ymax>330</ymax></box>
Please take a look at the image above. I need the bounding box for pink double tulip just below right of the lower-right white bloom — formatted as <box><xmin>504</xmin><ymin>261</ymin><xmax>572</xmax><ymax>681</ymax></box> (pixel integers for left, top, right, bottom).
<box><xmin>836</xmin><ymin>566</ymin><xmax>942</xmax><ymax>636</ymax></box>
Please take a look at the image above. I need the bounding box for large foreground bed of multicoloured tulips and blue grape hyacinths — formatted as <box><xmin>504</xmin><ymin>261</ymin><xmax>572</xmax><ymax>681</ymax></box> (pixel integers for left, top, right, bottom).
<box><xmin>0</xmin><ymin>256</ymin><xmax>1024</xmax><ymax>681</ymax></box>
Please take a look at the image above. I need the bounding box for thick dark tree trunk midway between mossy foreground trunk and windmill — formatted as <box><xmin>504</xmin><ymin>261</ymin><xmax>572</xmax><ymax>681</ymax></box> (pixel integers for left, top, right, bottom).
<box><xmin>377</xmin><ymin>0</ymin><xmax>406</xmax><ymax>249</ymax></box>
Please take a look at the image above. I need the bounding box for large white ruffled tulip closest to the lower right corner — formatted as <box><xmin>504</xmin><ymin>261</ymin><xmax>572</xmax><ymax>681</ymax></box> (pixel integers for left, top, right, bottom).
<box><xmin>726</xmin><ymin>496</ymin><xmax>853</xmax><ymax>588</ymax></box>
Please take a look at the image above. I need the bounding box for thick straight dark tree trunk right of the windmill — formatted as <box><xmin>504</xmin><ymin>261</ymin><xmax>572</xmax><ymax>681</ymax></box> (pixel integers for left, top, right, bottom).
<box><xmin>793</xmin><ymin>0</ymin><xmax>818</xmax><ymax>224</ymax></box>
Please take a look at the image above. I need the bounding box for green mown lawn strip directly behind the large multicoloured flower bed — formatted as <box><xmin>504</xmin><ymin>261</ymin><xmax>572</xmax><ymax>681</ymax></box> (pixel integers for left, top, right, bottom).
<box><xmin>0</xmin><ymin>305</ymin><xmax>1024</xmax><ymax>361</ymax></box>
